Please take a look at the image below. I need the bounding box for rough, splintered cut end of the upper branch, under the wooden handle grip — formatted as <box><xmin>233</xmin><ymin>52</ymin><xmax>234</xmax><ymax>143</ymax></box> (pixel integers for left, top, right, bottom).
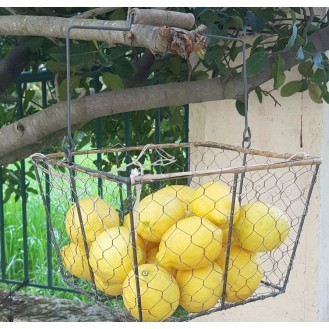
<box><xmin>159</xmin><ymin>25</ymin><xmax>207</xmax><ymax>59</ymax></box>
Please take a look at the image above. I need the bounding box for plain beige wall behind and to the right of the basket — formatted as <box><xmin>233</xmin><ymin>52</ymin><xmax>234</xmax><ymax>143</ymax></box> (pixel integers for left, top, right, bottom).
<box><xmin>189</xmin><ymin>71</ymin><xmax>329</xmax><ymax>321</ymax></box>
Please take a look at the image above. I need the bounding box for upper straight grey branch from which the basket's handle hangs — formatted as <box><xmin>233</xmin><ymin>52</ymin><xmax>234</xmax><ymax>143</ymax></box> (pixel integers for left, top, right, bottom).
<box><xmin>0</xmin><ymin>15</ymin><xmax>205</xmax><ymax>55</ymax></box>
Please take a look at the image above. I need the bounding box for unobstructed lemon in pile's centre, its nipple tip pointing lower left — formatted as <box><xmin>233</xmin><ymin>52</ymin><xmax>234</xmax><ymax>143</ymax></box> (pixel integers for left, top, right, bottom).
<box><xmin>156</xmin><ymin>216</ymin><xmax>222</xmax><ymax>270</ymax></box>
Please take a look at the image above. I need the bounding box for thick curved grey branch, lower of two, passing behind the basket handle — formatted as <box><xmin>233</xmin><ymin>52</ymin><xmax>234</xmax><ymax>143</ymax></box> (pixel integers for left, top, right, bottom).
<box><xmin>0</xmin><ymin>22</ymin><xmax>329</xmax><ymax>165</ymax></box>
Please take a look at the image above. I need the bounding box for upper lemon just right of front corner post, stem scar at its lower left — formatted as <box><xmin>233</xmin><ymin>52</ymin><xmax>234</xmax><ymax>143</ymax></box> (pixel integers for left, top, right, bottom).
<box><xmin>136</xmin><ymin>190</ymin><xmax>185</xmax><ymax>242</ymax></box>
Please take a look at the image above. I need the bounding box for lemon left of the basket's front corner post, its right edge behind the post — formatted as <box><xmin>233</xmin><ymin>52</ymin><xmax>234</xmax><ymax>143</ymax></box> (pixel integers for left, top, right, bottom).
<box><xmin>89</xmin><ymin>226</ymin><xmax>145</xmax><ymax>283</ymax></box>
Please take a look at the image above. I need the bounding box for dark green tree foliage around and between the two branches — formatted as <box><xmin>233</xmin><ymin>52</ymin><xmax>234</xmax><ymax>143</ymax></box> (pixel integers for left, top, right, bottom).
<box><xmin>0</xmin><ymin>7</ymin><xmax>329</xmax><ymax>197</ymax></box>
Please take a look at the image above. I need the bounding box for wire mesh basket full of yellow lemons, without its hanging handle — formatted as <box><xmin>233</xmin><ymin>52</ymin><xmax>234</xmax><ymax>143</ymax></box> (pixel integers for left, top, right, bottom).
<box><xmin>32</xmin><ymin>142</ymin><xmax>321</xmax><ymax>321</ymax></box>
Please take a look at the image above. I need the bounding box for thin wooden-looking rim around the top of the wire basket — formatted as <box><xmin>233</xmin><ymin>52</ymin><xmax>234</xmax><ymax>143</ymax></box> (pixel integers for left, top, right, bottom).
<box><xmin>30</xmin><ymin>141</ymin><xmax>322</xmax><ymax>185</ymax></box>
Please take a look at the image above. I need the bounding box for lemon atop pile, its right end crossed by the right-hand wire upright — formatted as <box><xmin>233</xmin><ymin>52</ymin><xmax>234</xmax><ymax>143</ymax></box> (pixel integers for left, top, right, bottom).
<box><xmin>189</xmin><ymin>182</ymin><xmax>240</xmax><ymax>225</ymax></box>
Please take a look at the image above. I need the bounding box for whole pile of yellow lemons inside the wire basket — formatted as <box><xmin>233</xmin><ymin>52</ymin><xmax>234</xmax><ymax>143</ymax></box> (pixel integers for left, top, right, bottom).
<box><xmin>61</xmin><ymin>182</ymin><xmax>290</xmax><ymax>321</ymax></box>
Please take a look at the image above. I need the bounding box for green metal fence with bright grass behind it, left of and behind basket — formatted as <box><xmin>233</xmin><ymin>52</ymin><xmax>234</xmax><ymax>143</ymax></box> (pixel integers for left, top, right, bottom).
<box><xmin>0</xmin><ymin>71</ymin><xmax>189</xmax><ymax>292</ymax></box>
